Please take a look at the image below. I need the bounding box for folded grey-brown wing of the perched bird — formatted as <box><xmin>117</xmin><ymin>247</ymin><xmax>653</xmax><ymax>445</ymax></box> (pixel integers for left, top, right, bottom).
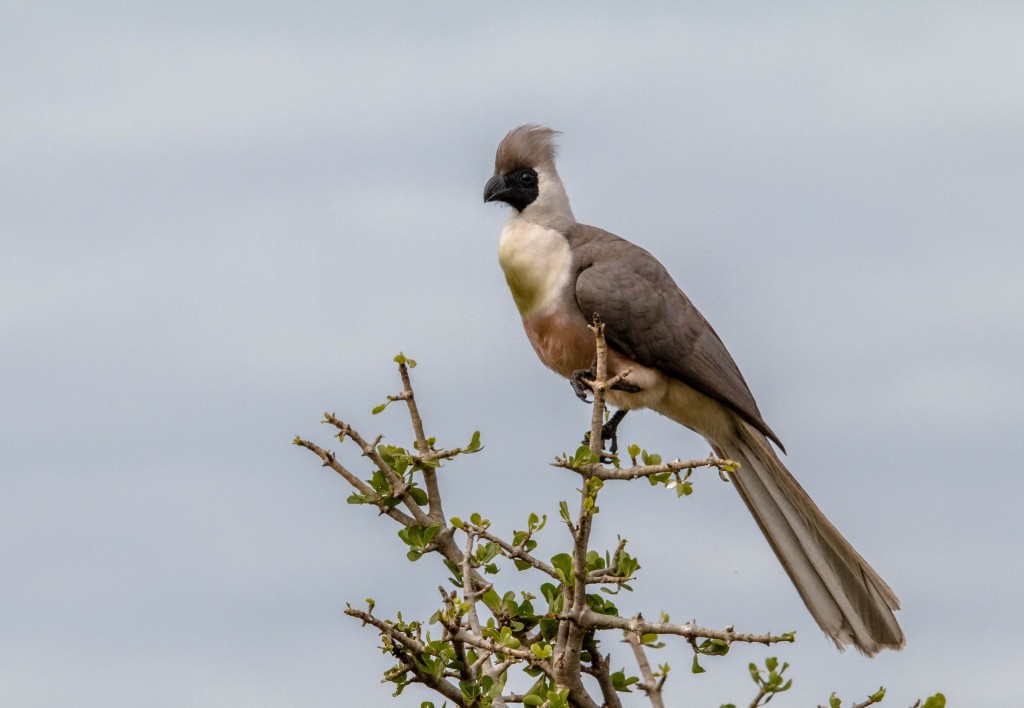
<box><xmin>575</xmin><ymin>235</ymin><xmax>782</xmax><ymax>449</ymax></box>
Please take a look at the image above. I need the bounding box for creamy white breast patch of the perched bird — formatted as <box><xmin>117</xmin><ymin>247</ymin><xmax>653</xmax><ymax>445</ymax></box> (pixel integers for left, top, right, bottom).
<box><xmin>498</xmin><ymin>218</ymin><xmax>572</xmax><ymax>318</ymax></box>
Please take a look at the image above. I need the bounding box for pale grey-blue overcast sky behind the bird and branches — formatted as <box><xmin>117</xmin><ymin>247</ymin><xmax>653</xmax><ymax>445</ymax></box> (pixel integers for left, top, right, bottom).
<box><xmin>0</xmin><ymin>2</ymin><xmax>1024</xmax><ymax>707</ymax></box>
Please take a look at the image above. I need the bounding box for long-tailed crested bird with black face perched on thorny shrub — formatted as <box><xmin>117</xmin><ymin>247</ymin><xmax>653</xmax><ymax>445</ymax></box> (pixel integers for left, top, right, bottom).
<box><xmin>483</xmin><ymin>124</ymin><xmax>906</xmax><ymax>656</ymax></box>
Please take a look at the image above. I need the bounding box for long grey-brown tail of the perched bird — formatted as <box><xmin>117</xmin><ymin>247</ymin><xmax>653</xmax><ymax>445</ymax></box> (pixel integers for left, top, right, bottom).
<box><xmin>715</xmin><ymin>423</ymin><xmax>906</xmax><ymax>657</ymax></box>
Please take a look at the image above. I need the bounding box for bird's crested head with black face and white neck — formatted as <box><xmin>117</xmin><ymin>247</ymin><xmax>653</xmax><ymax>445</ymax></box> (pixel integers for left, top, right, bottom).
<box><xmin>483</xmin><ymin>125</ymin><xmax>575</xmax><ymax>230</ymax></box>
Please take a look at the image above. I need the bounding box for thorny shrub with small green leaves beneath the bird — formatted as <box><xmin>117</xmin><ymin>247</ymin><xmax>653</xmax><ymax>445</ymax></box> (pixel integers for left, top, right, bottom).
<box><xmin>295</xmin><ymin>331</ymin><xmax>901</xmax><ymax>708</ymax></box>
